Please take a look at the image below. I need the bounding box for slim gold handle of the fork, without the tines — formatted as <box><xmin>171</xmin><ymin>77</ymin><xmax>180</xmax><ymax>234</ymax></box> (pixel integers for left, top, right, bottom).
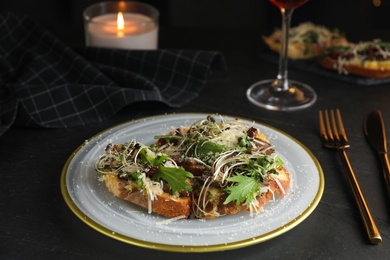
<box><xmin>338</xmin><ymin>149</ymin><xmax>382</xmax><ymax>244</ymax></box>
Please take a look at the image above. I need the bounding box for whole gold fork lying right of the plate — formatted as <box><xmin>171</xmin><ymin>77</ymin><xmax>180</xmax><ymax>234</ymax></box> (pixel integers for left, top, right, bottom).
<box><xmin>318</xmin><ymin>109</ymin><xmax>382</xmax><ymax>244</ymax></box>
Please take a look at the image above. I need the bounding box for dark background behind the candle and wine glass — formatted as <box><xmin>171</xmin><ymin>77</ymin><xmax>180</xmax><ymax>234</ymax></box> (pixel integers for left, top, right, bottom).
<box><xmin>0</xmin><ymin>0</ymin><xmax>390</xmax><ymax>45</ymax></box>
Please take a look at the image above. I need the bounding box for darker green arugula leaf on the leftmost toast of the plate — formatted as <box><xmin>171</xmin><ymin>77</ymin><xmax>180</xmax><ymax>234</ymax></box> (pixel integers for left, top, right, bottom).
<box><xmin>153</xmin><ymin>165</ymin><xmax>194</xmax><ymax>193</ymax></box>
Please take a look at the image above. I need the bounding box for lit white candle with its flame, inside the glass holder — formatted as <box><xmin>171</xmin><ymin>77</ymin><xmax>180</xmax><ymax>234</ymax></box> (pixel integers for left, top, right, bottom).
<box><xmin>86</xmin><ymin>12</ymin><xmax>158</xmax><ymax>50</ymax></box>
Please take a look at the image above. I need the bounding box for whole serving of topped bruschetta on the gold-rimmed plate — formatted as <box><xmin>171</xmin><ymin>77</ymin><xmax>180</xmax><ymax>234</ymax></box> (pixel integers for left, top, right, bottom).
<box><xmin>95</xmin><ymin>116</ymin><xmax>290</xmax><ymax>219</ymax></box>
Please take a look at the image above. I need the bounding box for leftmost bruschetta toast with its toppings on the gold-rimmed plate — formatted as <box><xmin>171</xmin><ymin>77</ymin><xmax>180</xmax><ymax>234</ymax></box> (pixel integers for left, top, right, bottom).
<box><xmin>95</xmin><ymin>140</ymin><xmax>193</xmax><ymax>218</ymax></box>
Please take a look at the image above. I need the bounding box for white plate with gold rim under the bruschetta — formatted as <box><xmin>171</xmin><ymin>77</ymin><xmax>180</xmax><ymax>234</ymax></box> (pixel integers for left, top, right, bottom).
<box><xmin>61</xmin><ymin>113</ymin><xmax>324</xmax><ymax>252</ymax></box>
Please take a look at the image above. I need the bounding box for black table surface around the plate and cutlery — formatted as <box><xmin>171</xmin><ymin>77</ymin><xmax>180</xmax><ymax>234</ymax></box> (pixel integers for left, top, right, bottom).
<box><xmin>0</xmin><ymin>29</ymin><xmax>390</xmax><ymax>260</ymax></box>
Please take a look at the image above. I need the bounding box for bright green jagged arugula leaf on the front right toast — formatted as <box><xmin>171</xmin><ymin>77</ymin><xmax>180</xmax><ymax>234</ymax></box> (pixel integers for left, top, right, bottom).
<box><xmin>224</xmin><ymin>175</ymin><xmax>260</xmax><ymax>207</ymax></box>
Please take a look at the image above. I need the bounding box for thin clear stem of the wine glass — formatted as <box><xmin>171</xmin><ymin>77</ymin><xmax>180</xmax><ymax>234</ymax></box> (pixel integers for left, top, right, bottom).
<box><xmin>274</xmin><ymin>7</ymin><xmax>294</xmax><ymax>91</ymax></box>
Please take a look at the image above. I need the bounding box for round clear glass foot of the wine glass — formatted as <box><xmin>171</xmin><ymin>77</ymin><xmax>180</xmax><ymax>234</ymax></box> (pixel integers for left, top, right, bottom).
<box><xmin>246</xmin><ymin>79</ymin><xmax>317</xmax><ymax>111</ymax></box>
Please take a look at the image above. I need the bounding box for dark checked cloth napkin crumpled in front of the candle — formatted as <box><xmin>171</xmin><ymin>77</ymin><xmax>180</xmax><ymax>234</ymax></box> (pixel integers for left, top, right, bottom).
<box><xmin>0</xmin><ymin>13</ymin><xmax>226</xmax><ymax>135</ymax></box>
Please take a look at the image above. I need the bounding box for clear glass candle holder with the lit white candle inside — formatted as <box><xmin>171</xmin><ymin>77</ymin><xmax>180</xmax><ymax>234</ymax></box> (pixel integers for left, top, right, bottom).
<box><xmin>83</xmin><ymin>1</ymin><xmax>159</xmax><ymax>50</ymax></box>
